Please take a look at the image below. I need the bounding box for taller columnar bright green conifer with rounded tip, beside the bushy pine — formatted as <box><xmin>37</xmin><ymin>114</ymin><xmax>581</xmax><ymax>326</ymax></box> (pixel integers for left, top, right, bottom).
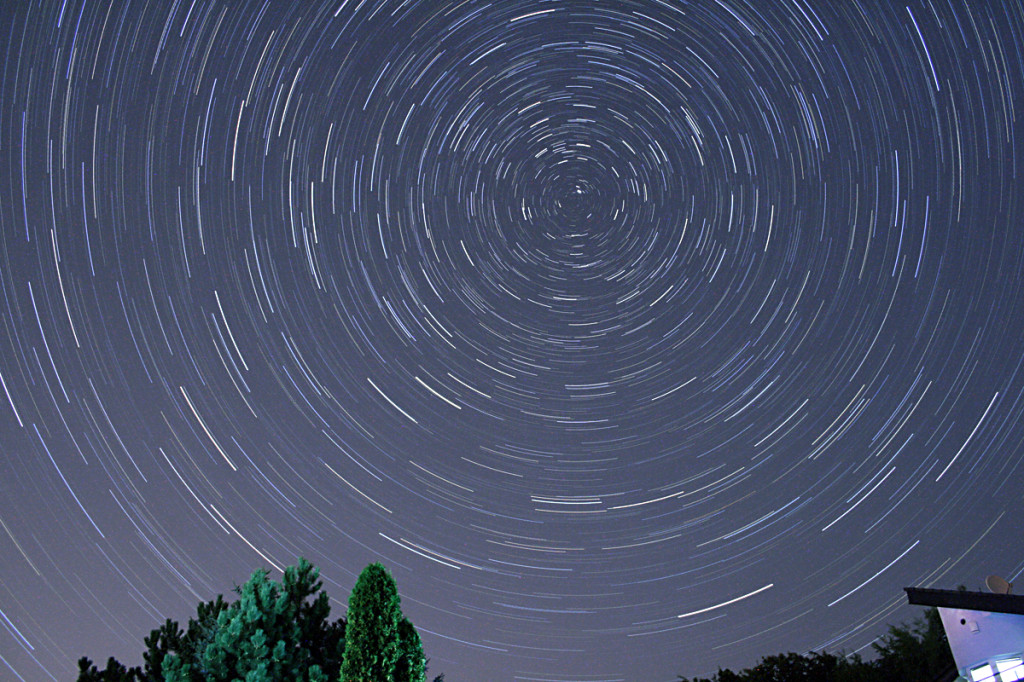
<box><xmin>341</xmin><ymin>563</ymin><xmax>402</xmax><ymax>682</ymax></box>
